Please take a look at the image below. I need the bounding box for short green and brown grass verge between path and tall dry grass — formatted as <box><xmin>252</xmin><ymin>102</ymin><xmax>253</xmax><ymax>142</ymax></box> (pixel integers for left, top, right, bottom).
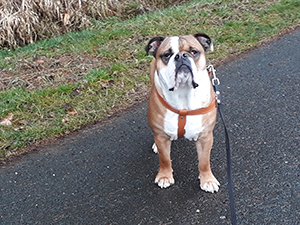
<box><xmin>0</xmin><ymin>0</ymin><xmax>300</xmax><ymax>159</ymax></box>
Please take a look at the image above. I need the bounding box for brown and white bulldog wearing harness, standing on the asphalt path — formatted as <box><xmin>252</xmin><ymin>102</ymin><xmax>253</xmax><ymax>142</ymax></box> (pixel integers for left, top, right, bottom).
<box><xmin>145</xmin><ymin>33</ymin><xmax>220</xmax><ymax>193</ymax></box>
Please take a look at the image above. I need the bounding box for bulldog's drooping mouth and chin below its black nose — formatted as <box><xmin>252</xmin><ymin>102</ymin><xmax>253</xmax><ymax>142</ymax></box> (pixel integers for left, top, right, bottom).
<box><xmin>169</xmin><ymin>64</ymin><xmax>199</xmax><ymax>91</ymax></box>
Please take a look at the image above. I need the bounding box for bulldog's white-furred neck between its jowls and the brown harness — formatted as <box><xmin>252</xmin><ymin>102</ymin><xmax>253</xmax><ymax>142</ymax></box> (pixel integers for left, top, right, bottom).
<box><xmin>155</xmin><ymin>69</ymin><xmax>214</xmax><ymax>110</ymax></box>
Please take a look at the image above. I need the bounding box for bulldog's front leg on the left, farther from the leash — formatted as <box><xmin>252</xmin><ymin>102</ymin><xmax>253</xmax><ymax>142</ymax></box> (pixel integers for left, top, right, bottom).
<box><xmin>154</xmin><ymin>135</ymin><xmax>175</xmax><ymax>188</ymax></box>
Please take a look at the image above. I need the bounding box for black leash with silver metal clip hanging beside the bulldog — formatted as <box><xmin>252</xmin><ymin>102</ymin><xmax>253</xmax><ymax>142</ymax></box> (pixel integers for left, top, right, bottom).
<box><xmin>208</xmin><ymin>65</ymin><xmax>237</xmax><ymax>225</ymax></box>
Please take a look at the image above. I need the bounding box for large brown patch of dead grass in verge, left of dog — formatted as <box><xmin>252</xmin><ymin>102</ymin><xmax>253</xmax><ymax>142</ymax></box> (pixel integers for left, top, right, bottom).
<box><xmin>0</xmin><ymin>54</ymin><xmax>105</xmax><ymax>90</ymax></box>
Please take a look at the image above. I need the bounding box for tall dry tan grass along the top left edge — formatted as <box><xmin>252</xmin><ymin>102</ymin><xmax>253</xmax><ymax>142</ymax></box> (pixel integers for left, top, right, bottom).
<box><xmin>0</xmin><ymin>0</ymin><xmax>186</xmax><ymax>48</ymax></box>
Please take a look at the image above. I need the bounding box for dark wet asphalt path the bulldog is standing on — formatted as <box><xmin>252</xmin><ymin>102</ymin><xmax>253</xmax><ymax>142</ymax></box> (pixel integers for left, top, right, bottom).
<box><xmin>0</xmin><ymin>30</ymin><xmax>300</xmax><ymax>225</ymax></box>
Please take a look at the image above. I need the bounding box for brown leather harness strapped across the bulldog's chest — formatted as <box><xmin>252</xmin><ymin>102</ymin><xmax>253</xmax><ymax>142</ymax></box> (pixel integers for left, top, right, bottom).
<box><xmin>156</xmin><ymin>89</ymin><xmax>217</xmax><ymax>138</ymax></box>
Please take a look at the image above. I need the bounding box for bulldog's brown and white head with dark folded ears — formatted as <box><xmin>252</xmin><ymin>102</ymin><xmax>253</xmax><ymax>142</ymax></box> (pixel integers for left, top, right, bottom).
<box><xmin>146</xmin><ymin>33</ymin><xmax>213</xmax><ymax>91</ymax></box>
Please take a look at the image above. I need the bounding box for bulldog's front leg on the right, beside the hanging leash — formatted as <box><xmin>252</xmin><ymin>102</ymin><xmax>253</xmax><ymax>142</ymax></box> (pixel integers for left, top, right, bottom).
<box><xmin>196</xmin><ymin>131</ymin><xmax>220</xmax><ymax>193</ymax></box>
